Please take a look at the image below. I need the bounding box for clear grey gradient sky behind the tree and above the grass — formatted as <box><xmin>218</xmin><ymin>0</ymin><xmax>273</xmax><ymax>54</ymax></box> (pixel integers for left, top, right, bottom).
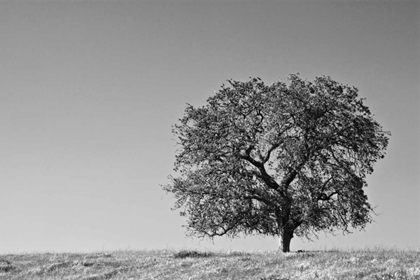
<box><xmin>0</xmin><ymin>0</ymin><xmax>420</xmax><ymax>253</ymax></box>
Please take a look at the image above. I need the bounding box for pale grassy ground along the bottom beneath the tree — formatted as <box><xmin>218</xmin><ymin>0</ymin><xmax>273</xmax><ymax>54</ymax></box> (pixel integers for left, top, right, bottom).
<box><xmin>0</xmin><ymin>249</ymin><xmax>420</xmax><ymax>280</ymax></box>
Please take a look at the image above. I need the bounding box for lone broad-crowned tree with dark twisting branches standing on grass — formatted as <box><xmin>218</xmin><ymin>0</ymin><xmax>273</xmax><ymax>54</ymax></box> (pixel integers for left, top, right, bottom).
<box><xmin>164</xmin><ymin>74</ymin><xmax>390</xmax><ymax>252</ymax></box>
